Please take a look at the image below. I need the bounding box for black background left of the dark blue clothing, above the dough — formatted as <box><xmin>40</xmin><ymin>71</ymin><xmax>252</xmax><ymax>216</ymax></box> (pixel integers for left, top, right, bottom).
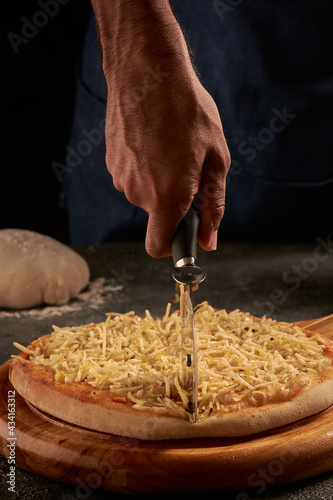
<box><xmin>0</xmin><ymin>0</ymin><xmax>91</xmax><ymax>243</ymax></box>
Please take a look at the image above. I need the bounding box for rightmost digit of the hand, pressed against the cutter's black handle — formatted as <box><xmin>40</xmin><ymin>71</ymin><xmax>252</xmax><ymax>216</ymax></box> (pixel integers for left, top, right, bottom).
<box><xmin>197</xmin><ymin>148</ymin><xmax>227</xmax><ymax>251</ymax></box>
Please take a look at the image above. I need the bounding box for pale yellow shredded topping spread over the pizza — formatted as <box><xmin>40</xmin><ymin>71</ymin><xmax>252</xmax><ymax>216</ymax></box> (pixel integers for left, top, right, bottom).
<box><xmin>14</xmin><ymin>302</ymin><xmax>332</xmax><ymax>420</ymax></box>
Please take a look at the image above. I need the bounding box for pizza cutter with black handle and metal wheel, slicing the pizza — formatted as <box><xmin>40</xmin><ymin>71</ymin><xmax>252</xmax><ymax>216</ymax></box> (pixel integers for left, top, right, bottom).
<box><xmin>171</xmin><ymin>205</ymin><xmax>206</xmax><ymax>422</ymax></box>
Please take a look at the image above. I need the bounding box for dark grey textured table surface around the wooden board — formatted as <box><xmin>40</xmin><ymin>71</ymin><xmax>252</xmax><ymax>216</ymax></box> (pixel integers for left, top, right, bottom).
<box><xmin>0</xmin><ymin>240</ymin><xmax>333</xmax><ymax>500</ymax></box>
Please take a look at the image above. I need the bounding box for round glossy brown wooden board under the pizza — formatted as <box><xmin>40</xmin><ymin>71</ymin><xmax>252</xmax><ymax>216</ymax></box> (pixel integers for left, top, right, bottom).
<box><xmin>0</xmin><ymin>315</ymin><xmax>333</xmax><ymax>498</ymax></box>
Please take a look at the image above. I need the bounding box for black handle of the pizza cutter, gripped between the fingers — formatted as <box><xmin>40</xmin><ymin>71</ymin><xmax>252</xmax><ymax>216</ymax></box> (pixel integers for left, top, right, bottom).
<box><xmin>171</xmin><ymin>205</ymin><xmax>200</xmax><ymax>267</ymax></box>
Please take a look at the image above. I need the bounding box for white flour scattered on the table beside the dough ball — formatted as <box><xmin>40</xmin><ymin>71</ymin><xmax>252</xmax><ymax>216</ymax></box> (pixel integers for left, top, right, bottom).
<box><xmin>0</xmin><ymin>277</ymin><xmax>124</xmax><ymax>319</ymax></box>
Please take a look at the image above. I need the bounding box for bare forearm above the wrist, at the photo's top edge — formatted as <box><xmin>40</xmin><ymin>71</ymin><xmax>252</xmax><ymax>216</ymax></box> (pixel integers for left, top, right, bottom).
<box><xmin>91</xmin><ymin>0</ymin><xmax>192</xmax><ymax>78</ymax></box>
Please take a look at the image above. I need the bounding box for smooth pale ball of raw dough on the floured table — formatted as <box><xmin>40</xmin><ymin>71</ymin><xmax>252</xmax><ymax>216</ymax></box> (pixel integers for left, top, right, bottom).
<box><xmin>0</xmin><ymin>229</ymin><xmax>90</xmax><ymax>309</ymax></box>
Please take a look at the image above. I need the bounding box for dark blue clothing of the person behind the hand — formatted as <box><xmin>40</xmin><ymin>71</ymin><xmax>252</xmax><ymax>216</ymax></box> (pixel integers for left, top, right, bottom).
<box><xmin>63</xmin><ymin>0</ymin><xmax>333</xmax><ymax>243</ymax></box>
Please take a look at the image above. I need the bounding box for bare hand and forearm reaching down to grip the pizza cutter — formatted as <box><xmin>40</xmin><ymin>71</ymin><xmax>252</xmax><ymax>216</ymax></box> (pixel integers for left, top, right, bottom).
<box><xmin>91</xmin><ymin>0</ymin><xmax>230</xmax><ymax>257</ymax></box>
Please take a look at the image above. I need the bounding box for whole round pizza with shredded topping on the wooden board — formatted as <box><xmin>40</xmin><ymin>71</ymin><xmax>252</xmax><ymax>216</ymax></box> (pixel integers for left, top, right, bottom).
<box><xmin>9</xmin><ymin>302</ymin><xmax>333</xmax><ymax>440</ymax></box>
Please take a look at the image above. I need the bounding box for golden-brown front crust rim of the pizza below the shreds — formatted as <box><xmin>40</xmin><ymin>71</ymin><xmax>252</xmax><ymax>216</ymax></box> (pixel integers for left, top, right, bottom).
<box><xmin>9</xmin><ymin>353</ymin><xmax>333</xmax><ymax>440</ymax></box>
